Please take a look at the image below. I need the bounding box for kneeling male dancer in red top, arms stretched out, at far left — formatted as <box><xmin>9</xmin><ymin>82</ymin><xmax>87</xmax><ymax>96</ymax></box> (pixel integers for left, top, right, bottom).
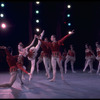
<box><xmin>0</xmin><ymin>46</ymin><xmax>31</xmax><ymax>87</ymax></box>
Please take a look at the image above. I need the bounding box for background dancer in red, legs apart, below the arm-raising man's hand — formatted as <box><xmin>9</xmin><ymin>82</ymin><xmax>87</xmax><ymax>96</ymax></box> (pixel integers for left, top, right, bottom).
<box><xmin>64</xmin><ymin>45</ymin><xmax>76</xmax><ymax>74</ymax></box>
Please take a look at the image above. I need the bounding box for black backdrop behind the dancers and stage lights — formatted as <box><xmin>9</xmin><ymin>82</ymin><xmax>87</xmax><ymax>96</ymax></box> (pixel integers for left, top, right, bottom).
<box><xmin>0</xmin><ymin>0</ymin><xmax>100</xmax><ymax>71</ymax></box>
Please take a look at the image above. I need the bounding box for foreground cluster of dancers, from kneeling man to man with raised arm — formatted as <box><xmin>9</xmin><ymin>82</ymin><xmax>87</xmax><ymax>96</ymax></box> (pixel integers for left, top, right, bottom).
<box><xmin>0</xmin><ymin>30</ymin><xmax>74</xmax><ymax>87</ymax></box>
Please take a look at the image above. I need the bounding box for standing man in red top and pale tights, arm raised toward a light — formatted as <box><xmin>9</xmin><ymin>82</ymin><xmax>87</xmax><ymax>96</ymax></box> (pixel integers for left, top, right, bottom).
<box><xmin>36</xmin><ymin>31</ymin><xmax>74</xmax><ymax>82</ymax></box>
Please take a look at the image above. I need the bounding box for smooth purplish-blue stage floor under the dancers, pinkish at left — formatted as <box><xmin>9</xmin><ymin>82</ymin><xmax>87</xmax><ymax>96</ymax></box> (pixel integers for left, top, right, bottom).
<box><xmin>0</xmin><ymin>71</ymin><xmax>100</xmax><ymax>99</ymax></box>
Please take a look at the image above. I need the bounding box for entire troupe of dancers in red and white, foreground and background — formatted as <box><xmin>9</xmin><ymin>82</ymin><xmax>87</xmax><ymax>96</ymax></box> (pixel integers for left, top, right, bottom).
<box><xmin>0</xmin><ymin>30</ymin><xmax>100</xmax><ymax>87</ymax></box>
